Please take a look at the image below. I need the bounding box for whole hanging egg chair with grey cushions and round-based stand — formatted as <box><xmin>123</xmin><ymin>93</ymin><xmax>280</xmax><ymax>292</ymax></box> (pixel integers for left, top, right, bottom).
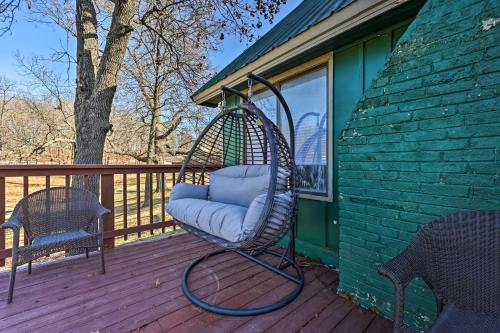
<box><xmin>167</xmin><ymin>74</ymin><xmax>304</xmax><ymax>316</ymax></box>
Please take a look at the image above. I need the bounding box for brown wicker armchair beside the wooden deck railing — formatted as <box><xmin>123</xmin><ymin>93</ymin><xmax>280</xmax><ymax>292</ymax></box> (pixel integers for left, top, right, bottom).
<box><xmin>1</xmin><ymin>187</ymin><xmax>110</xmax><ymax>303</ymax></box>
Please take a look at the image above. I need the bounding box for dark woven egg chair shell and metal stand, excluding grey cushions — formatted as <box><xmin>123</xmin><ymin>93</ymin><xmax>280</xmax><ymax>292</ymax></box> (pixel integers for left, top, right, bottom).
<box><xmin>173</xmin><ymin>73</ymin><xmax>304</xmax><ymax>316</ymax></box>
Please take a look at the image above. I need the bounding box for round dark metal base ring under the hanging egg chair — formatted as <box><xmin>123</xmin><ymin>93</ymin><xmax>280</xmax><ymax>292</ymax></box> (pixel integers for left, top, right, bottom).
<box><xmin>182</xmin><ymin>249</ymin><xmax>304</xmax><ymax>316</ymax></box>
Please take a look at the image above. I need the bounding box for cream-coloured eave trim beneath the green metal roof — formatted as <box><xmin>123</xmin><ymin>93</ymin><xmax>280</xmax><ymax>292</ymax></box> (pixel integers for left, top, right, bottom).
<box><xmin>191</xmin><ymin>0</ymin><xmax>422</xmax><ymax>106</ymax></box>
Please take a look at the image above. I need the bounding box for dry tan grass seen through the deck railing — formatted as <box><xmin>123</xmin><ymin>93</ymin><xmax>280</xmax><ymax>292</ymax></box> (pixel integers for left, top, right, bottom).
<box><xmin>0</xmin><ymin>174</ymin><xmax>179</xmax><ymax>268</ymax></box>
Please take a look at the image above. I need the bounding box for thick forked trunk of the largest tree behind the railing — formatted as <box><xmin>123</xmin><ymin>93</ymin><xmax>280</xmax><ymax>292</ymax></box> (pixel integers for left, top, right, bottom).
<box><xmin>74</xmin><ymin>0</ymin><xmax>137</xmax><ymax>194</ymax></box>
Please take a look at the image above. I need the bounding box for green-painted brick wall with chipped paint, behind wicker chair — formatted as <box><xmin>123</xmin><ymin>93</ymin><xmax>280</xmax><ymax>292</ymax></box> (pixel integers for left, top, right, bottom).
<box><xmin>337</xmin><ymin>0</ymin><xmax>500</xmax><ymax>329</ymax></box>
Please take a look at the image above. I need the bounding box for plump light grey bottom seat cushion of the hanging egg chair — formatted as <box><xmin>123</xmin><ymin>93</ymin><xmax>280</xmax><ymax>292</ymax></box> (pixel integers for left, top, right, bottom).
<box><xmin>167</xmin><ymin>199</ymin><xmax>253</xmax><ymax>242</ymax></box>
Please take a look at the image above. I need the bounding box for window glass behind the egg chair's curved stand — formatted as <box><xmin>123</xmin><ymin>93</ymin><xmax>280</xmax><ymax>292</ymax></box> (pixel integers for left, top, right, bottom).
<box><xmin>253</xmin><ymin>66</ymin><xmax>329</xmax><ymax>196</ymax></box>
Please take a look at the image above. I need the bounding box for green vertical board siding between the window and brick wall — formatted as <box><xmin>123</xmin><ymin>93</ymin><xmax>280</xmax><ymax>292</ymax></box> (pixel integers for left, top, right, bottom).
<box><xmin>296</xmin><ymin>21</ymin><xmax>409</xmax><ymax>267</ymax></box>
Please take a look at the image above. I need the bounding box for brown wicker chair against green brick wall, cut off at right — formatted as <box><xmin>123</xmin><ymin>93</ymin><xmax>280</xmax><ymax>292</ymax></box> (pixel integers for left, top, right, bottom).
<box><xmin>379</xmin><ymin>211</ymin><xmax>500</xmax><ymax>333</ymax></box>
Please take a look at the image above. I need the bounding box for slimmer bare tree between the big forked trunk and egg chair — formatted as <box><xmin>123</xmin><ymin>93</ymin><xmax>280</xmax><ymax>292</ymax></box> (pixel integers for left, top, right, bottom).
<box><xmin>117</xmin><ymin>3</ymin><xmax>219</xmax><ymax>206</ymax></box>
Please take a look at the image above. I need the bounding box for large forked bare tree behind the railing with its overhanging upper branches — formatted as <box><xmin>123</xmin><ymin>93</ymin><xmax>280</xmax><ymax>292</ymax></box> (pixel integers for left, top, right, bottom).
<box><xmin>0</xmin><ymin>0</ymin><xmax>285</xmax><ymax>192</ymax></box>
